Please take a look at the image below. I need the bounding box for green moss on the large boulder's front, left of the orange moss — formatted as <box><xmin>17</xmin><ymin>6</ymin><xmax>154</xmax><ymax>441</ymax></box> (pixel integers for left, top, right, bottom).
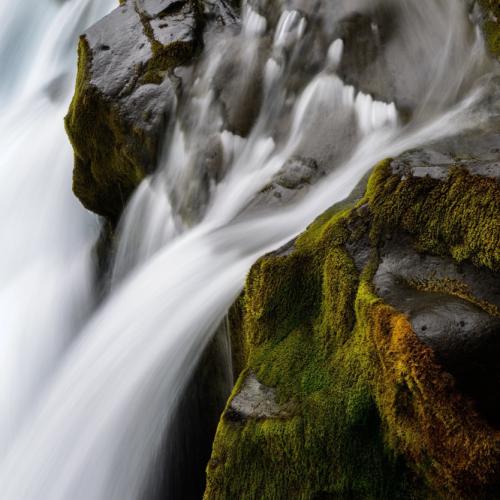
<box><xmin>206</xmin><ymin>214</ymin><xmax>426</xmax><ymax>499</ymax></box>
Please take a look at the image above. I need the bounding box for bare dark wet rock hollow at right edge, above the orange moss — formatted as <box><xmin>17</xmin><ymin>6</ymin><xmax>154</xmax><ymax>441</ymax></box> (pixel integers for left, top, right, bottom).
<box><xmin>374</xmin><ymin>235</ymin><xmax>500</xmax><ymax>425</ymax></box>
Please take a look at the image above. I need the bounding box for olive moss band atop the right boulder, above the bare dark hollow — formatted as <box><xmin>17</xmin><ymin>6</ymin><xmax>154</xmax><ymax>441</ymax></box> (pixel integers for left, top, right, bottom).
<box><xmin>367</xmin><ymin>165</ymin><xmax>500</xmax><ymax>271</ymax></box>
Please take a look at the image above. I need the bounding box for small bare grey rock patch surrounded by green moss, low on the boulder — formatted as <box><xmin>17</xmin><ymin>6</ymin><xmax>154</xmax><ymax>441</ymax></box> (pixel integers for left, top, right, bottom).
<box><xmin>225</xmin><ymin>372</ymin><xmax>292</xmax><ymax>422</ymax></box>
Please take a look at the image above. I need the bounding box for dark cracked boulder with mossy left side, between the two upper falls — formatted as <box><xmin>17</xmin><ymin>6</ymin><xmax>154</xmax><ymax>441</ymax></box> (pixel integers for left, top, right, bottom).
<box><xmin>66</xmin><ymin>0</ymin><xmax>202</xmax><ymax>220</ymax></box>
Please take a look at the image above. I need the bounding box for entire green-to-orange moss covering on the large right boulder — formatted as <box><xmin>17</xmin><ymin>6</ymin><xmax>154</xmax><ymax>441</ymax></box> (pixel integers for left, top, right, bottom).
<box><xmin>205</xmin><ymin>161</ymin><xmax>500</xmax><ymax>500</ymax></box>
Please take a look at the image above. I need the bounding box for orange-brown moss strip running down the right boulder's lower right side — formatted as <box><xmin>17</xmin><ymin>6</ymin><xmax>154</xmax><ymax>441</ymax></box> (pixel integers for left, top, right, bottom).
<box><xmin>365</xmin><ymin>292</ymin><xmax>500</xmax><ymax>498</ymax></box>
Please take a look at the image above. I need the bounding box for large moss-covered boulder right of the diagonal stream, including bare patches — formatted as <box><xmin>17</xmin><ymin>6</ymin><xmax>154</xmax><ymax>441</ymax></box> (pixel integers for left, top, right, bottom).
<box><xmin>205</xmin><ymin>138</ymin><xmax>500</xmax><ymax>500</ymax></box>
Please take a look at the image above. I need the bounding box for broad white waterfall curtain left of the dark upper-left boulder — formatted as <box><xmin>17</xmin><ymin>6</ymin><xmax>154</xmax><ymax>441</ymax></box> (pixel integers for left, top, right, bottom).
<box><xmin>0</xmin><ymin>0</ymin><xmax>118</xmax><ymax>450</ymax></box>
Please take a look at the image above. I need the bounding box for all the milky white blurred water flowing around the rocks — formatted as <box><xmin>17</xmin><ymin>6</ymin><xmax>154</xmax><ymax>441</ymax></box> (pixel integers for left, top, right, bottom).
<box><xmin>0</xmin><ymin>0</ymin><xmax>496</xmax><ymax>500</ymax></box>
